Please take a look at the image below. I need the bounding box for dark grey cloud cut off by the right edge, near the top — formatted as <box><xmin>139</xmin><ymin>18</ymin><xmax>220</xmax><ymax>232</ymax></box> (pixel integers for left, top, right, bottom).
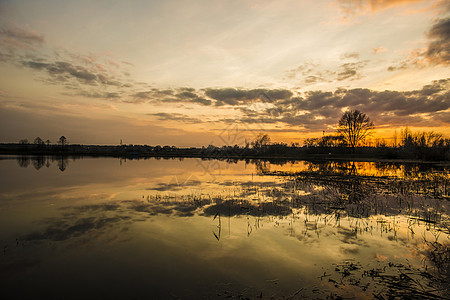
<box><xmin>425</xmin><ymin>18</ymin><xmax>450</xmax><ymax>65</ymax></box>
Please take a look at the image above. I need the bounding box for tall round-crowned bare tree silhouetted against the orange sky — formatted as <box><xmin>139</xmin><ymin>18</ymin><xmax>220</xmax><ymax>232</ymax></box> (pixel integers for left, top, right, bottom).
<box><xmin>337</xmin><ymin>110</ymin><xmax>374</xmax><ymax>152</ymax></box>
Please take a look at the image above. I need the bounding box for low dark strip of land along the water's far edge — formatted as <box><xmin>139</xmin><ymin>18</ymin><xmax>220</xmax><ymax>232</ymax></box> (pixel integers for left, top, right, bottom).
<box><xmin>0</xmin><ymin>143</ymin><xmax>450</xmax><ymax>166</ymax></box>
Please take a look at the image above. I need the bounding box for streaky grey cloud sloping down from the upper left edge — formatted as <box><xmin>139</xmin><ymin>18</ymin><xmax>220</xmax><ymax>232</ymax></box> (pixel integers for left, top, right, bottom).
<box><xmin>0</xmin><ymin>26</ymin><xmax>133</xmax><ymax>99</ymax></box>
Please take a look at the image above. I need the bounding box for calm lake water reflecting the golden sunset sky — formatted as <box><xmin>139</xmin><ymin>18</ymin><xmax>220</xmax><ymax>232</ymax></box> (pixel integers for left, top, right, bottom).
<box><xmin>0</xmin><ymin>157</ymin><xmax>450</xmax><ymax>299</ymax></box>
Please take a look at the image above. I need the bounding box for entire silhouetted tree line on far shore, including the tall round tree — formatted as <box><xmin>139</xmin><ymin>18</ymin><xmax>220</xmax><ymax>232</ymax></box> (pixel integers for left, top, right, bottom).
<box><xmin>7</xmin><ymin>110</ymin><xmax>450</xmax><ymax>160</ymax></box>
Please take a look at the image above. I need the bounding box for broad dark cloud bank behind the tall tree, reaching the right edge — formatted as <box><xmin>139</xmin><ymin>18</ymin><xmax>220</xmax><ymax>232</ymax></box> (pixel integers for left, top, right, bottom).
<box><xmin>230</xmin><ymin>78</ymin><xmax>450</xmax><ymax>131</ymax></box>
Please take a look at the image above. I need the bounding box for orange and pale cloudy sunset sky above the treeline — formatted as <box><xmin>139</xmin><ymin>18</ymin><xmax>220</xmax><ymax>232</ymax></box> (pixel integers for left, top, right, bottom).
<box><xmin>0</xmin><ymin>0</ymin><xmax>450</xmax><ymax>147</ymax></box>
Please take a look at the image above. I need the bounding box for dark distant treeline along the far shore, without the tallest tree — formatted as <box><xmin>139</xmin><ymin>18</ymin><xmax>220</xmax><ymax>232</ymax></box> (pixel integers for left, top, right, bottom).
<box><xmin>0</xmin><ymin>128</ymin><xmax>450</xmax><ymax>161</ymax></box>
